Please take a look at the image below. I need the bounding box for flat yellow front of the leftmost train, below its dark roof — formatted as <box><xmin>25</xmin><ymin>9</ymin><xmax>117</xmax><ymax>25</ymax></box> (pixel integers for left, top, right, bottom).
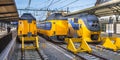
<box><xmin>18</xmin><ymin>20</ymin><xmax>37</xmax><ymax>36</ymax></box>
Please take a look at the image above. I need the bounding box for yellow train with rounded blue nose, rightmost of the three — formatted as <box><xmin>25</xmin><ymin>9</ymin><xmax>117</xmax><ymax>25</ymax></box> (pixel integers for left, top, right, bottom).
<box><xmin>68</xmin><ymin>14</ymin><xmax>101</xmax><ymax>42</ymax></box>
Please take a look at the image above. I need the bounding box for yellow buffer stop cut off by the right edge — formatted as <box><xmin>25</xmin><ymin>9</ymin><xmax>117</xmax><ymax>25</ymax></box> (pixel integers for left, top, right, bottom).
<box><xmin>102</xmin><ymin>37</ymin><xmax>120</xmax><ymax>51</ymax></box>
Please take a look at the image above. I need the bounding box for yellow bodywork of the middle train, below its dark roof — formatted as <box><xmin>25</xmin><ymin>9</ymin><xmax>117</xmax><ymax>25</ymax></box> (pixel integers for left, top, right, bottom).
<box><xmin>38</xmin><ymin>20</ymin><xmax>68</xmax><ymax>37</ymax></box>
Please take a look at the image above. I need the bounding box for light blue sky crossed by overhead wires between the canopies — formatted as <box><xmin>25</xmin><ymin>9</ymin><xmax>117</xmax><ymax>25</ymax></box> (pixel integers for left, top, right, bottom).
<box><xmin>15</xmin><ymin>0</ymin><xmax>96</xmax><ymax>20</ymax></box>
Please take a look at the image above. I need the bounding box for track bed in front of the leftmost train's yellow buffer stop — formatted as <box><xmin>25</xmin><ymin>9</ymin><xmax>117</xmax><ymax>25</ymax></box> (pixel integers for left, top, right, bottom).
<box><xmin>20</xmin><ymin>43</ymin><xmax>48</xmax><ymax>60</ymax></box>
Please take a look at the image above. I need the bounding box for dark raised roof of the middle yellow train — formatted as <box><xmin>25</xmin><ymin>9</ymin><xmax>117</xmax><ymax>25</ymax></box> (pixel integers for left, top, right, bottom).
<box><xmin>46</xmin><ymin>13</ymin><xmax>67</xmax><ymax>20</ymax></box>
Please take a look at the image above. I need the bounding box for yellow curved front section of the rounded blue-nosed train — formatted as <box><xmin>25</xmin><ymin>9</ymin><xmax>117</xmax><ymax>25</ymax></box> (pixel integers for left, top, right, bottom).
<box><xmin>77</xmin><ymin>19</ymin><xmax>101</xmax><ymax>42</ymax></box>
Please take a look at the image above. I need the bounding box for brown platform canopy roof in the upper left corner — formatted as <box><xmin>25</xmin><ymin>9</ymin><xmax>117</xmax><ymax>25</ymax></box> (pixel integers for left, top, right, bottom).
<box><xmin>0</xmin><ymin>0</ymin><xmax>19</xmax><ymax>21</ymax></box>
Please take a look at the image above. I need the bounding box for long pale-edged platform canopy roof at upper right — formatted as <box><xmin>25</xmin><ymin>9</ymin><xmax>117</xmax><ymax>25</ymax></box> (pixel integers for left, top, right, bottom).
<box><xmin>65</xmin><ymin>0</ymin><xmax>120</xmax><ymax>17</ymax></box>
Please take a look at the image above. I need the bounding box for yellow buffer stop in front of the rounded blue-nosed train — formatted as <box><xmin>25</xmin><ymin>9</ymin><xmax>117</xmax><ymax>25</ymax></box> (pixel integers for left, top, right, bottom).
<box><xmin>65</xmin><ymin>38</ymin><xmax>92</xmax><ymax>54</ymax></box>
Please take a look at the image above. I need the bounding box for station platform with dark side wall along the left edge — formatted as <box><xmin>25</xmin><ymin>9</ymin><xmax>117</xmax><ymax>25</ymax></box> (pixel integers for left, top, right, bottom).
<box><xmin>0</xmin><ymin>29</ymin><xmax>17</xmax><ymax>60</ymax></box>
